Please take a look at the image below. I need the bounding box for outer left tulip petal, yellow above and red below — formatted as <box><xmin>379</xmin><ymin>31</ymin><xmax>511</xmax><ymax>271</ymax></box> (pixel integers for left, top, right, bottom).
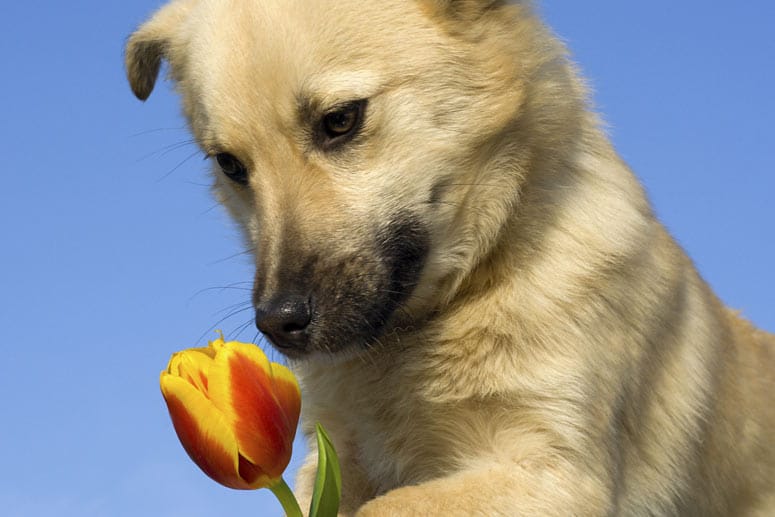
<box><xmin>160</xmin><ymin>373</ymin><xmax>269</xmax><ymax>489</ymax></box>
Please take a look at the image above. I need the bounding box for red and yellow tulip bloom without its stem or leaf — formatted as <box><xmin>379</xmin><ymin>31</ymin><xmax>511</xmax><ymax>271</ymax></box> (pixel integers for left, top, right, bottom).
<box><xmin>160</xmin><ymin>335</ymin><xmax>301</xmax><ymax>490</ymax></box>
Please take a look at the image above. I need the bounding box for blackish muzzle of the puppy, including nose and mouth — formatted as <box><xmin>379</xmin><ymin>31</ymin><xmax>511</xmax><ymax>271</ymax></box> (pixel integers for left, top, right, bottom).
<box><xmin>254</xmin><ymin>217</ymin><xmax>430</xmax><ymax>359</ymax></box>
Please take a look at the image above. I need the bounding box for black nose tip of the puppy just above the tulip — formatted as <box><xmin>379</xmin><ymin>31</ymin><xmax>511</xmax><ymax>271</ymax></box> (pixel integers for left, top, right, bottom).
<box><xmin>256</xmin><ymin>295</ymin><xmax>312</xmax><ymax>350</ymax></box>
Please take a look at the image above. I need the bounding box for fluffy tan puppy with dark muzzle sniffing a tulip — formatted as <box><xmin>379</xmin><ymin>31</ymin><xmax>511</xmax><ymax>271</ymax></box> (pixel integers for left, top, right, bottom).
<box><xmin>126</xmin><ymin>0</ymin><xmax>775</xmax><ymax>517</ymax></box>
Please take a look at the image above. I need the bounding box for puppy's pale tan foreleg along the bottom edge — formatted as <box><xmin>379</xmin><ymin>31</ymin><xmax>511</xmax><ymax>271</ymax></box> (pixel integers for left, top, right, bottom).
<box><xmin>357</xmin><ymin>459</ymin><xmax>615</xmax><ymax>517</ymax></box>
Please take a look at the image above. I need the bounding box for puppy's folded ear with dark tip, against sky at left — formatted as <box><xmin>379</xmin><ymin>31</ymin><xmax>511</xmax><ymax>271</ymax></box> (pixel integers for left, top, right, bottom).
<box><xmin>124</xmin><ymin>0</ymin><xmax>191</xmax><ymax>101</ymax></box>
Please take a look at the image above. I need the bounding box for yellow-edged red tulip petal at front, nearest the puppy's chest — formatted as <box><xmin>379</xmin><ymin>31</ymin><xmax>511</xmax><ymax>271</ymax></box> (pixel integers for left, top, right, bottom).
<box><xmin>210</xmin><ymin>341</ymin><xmax>298</xmax><ymax>479</ymax></box>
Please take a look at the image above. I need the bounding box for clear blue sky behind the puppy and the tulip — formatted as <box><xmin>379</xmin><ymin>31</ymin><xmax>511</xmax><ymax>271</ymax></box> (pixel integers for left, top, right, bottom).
<box><xmin>0</xmin><ymin>0</ymin><xmax>775</xmax><ymax>517</ymax></box>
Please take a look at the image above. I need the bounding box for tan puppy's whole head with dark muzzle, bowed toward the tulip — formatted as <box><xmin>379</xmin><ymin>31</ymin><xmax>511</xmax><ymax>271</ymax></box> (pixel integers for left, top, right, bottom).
<box><xmin>126</xmin><ymin>0</ymin><xmax>576</xmax><ymax>357</ymax></box>
